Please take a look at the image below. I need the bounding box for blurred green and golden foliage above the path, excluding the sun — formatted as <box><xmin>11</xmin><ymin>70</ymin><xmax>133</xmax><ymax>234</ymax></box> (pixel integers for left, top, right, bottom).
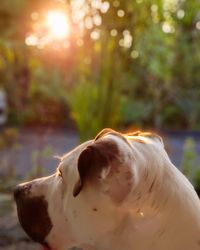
<box><xmin>0</xmin><ymin>0</ymin><xmax>200</xmax><ymax>140</ymax></box>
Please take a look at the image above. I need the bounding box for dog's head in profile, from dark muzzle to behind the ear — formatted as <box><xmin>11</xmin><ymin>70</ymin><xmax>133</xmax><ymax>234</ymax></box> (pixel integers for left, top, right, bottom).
<box><xmin>14</xmin><ymin>129</ymin><xmax>164</xmax><ymax>250</ymax></box>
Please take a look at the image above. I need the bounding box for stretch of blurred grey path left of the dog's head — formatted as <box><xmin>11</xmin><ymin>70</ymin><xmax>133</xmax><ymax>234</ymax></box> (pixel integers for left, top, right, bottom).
<box><xmin>0</xmin><ymin>130</ymin><xmax>79</xmax><ymax>177</ymax></box>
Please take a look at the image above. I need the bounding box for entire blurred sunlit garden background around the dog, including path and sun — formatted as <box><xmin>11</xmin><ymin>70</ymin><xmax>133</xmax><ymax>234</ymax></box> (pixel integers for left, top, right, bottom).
<box><xmin>0</xmin><ymin>0</ymin><xmax>200</xmax><ymax>250</ymax></box>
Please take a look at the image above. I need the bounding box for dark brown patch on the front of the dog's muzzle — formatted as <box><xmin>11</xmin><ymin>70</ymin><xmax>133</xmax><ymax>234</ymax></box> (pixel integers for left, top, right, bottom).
<box><xmin>14</xmin><ymin>183</ymin><xmax>52</xmax><ymax>244</ymax></box>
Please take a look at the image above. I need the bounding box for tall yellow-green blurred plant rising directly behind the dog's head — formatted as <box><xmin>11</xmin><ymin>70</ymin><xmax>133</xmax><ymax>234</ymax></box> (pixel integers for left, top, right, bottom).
<box><xmin>65</xmin><ymin>30</ymin><xmax>123</xmax><ymax>140</ymax></box>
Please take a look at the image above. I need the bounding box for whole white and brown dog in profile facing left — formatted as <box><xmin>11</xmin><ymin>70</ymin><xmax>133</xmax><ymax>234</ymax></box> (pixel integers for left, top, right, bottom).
<box><xmin>14</xmin><ymin>129</ymin><xmax>200</xmax><ymax>250</ymax></box>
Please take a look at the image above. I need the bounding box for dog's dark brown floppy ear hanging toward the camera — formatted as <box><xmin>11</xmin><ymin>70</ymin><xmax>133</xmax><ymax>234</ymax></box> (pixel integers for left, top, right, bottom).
<box><xmin>73</xmin><ymin>139</ymin><xmax>119</xmax><ymax>197</ymax></box>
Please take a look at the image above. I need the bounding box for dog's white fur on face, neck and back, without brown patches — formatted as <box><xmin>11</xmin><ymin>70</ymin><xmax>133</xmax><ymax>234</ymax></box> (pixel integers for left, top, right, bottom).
<box><xmin>27</xmin><ymin>135</ymin><xmax>200</xmax><ymax>250</ymax></box>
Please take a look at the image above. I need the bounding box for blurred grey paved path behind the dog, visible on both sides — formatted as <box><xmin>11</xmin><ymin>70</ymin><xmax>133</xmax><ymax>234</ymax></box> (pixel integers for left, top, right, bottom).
<box><xmin>0</xmin><ymin>130</ymin><xmax>200</xmax><ymax>178</ymax></box>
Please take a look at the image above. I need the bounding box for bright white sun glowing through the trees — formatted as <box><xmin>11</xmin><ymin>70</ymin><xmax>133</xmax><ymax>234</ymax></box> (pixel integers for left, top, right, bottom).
<box><xmin>46</xmin><ymin>11</ymin><xmax>69</xmax><ymax>40</ymax></box>
